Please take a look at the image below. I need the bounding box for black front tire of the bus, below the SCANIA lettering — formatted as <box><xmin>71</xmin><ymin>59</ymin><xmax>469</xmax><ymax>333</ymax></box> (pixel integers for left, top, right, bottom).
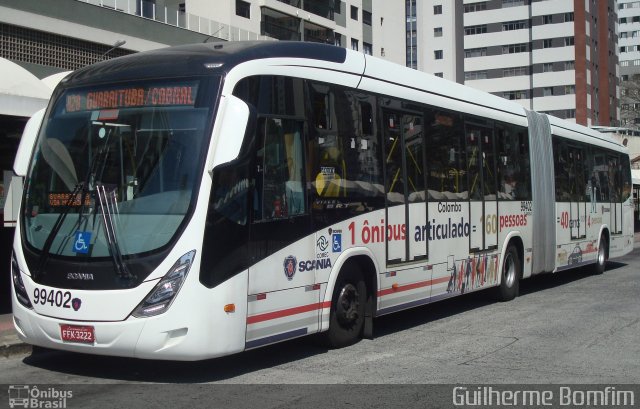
<box><xmin>324</xmin><ymin>266</ymin><xmax>367</xmax><ymax>348</ymax></box>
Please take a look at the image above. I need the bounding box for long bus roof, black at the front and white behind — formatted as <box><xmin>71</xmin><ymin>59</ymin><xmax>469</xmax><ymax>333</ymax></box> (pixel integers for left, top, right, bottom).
<box><xmin>62</xmin><ymin>41</ymin><xmax>624</xmax><ymax>150</ymax></box>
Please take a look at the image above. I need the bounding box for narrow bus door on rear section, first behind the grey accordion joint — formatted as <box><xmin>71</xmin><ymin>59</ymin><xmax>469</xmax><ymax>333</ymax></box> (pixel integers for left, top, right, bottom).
<box><xmin>567</xmin><ymin>145</ymin><xmax>587</xmax><ymax>240</ymax></box>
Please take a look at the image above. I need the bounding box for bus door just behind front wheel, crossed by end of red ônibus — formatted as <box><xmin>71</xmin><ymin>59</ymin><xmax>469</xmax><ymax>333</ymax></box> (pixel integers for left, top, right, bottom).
<box><xmin>383</xmin><ymin>111</ymin><xmax>428</xmax><ymax>265</ymax></box>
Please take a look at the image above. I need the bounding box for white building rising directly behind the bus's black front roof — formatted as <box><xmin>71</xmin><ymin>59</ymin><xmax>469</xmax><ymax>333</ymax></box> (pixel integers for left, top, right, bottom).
<box><xmin>182</xmin><ymin>0</ymin><xmax>404</xmax><ymax>63</ymax></box>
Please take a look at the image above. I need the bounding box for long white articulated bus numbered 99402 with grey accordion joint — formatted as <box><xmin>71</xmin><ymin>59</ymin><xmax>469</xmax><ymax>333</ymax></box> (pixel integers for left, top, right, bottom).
<box><xmin>11</xmin><ymin>42</ymin><xmax>633</xmax><ymax>360</ymax></box>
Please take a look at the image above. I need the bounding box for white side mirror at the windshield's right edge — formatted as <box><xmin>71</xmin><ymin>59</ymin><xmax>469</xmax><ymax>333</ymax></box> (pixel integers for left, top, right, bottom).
<box><xmin>208</xmin><ymin>95</ymin><xmax>250</xmax><ymax>171</ymax></box>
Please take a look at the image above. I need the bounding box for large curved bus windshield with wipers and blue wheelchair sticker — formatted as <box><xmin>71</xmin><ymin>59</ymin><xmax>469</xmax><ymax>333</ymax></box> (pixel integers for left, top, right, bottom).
<box><xmin>22</xmin><ymin>79</ymin><xmax>217</xmax><ymax>264</ymax></box>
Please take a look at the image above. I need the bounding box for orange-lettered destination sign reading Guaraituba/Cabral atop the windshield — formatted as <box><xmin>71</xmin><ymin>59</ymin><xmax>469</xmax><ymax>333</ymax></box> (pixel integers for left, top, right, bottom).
<box><xmin>65</xmin><ymin>82</ymin><xmax>198</xmax><ymax>113</ymax></box>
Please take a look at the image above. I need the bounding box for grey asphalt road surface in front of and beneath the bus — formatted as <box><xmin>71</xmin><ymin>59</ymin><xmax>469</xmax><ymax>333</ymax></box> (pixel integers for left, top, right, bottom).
<box><xmin>0</xmin><ymin>248</ymin><xmax>640</xmax><ymax>407</ymax></box>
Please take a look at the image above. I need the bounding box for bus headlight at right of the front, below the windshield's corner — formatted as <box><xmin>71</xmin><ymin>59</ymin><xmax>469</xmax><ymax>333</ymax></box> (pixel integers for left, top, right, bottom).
<box><xmin>132</xmin><ymin>250</ymin><xmax>196</xmax><ymax>318</ymax></box>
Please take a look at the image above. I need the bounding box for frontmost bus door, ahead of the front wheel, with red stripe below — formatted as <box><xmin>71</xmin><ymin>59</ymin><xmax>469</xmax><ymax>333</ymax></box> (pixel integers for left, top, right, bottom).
<box><xmin>247</xmin><ymin>117</ymin><xmax>319</xmax><ymax>347</ymax></box>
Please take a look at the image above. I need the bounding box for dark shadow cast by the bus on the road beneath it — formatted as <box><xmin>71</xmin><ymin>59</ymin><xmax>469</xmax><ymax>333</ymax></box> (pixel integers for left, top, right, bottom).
<box><xmin>18</xmin><ymin>262</ymin><xmax>626</xmax><ymax>383</ymax></box>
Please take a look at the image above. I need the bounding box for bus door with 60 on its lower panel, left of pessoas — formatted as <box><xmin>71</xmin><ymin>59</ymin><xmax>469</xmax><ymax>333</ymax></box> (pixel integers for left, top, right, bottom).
<box><xmin>465</xmin><ymin>122</ymin><xmax>498</xmax><ymax>252</ymax></box>
